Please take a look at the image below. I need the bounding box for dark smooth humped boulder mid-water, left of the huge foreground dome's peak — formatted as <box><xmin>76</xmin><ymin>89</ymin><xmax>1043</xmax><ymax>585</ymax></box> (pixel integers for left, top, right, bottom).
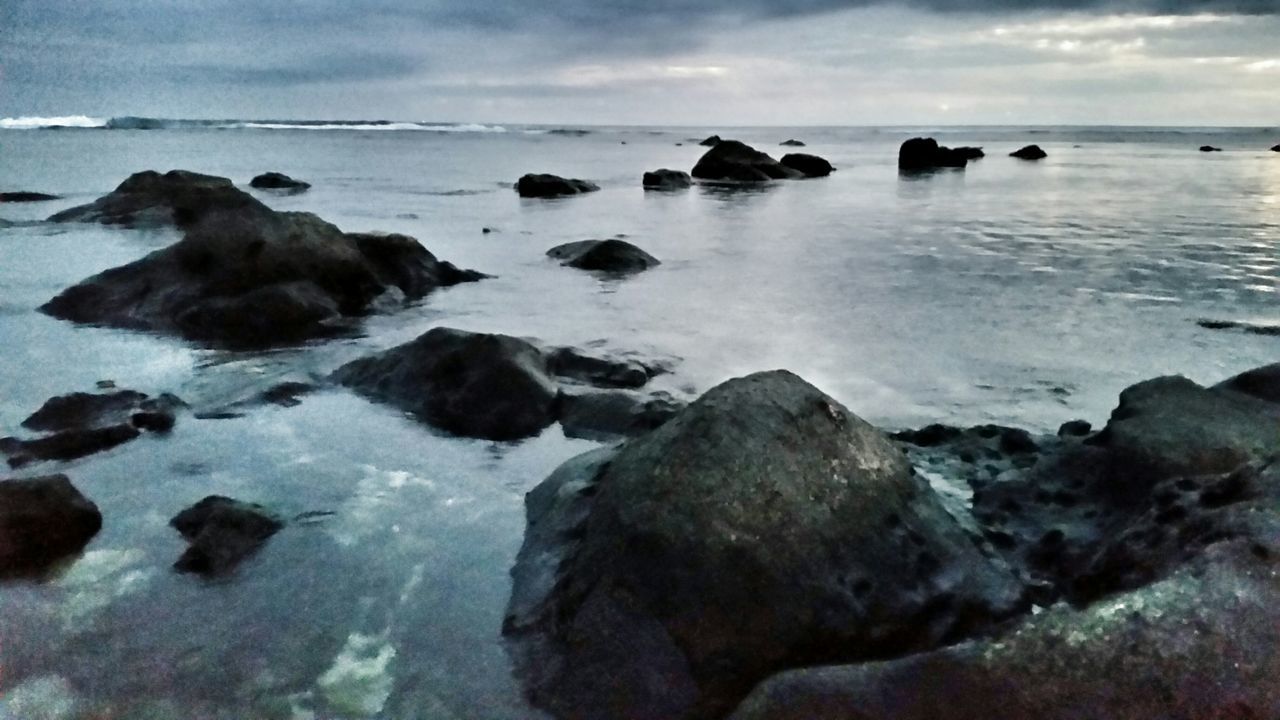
<box><xmin>333</xmin><ymin>328</ymin><xmax>558</xmax><ymax>441</ymax></box>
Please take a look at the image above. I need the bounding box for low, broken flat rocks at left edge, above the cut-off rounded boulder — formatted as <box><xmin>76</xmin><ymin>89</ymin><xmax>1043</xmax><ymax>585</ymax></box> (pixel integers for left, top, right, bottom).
<box><xmin>0</xmin><ymin>389</ymin><xmax>184</xmax><ymax>468</ymax></box>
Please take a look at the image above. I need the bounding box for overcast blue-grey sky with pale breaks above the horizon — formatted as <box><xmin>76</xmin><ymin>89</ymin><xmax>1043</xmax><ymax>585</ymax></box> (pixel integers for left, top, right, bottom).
<box><xmin>0</xmin><ymin>0</ymin><xmax>1280</xmax><ymax>127</ymax></box>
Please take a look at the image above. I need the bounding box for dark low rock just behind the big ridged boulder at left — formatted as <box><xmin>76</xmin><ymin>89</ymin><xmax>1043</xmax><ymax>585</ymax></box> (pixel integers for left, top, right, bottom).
<box><xmin>49</xmin><ymin>170</ymin><xmax>270</xmax><ymax>227</ymax></box>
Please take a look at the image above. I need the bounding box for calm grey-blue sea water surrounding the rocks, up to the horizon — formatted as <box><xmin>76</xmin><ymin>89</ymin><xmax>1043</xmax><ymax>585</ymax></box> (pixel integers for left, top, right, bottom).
<box><xmin>0</xmin><ymin>118</ymin><xmax>1280</xmax><ymax>720</ymax></box>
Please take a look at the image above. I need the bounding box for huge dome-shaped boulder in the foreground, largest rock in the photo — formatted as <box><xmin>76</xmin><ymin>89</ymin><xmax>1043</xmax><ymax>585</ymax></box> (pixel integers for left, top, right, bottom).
<box><xmin>504</xmin><ymin>370</ymin><xmax>1025</xmax><ymax>720</ymax></box>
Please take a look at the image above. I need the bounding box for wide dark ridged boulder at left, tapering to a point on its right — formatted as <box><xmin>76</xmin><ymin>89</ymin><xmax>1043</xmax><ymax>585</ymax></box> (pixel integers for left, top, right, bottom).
<box><xmin>41</xmin><ymin>180</ymin><xmax>485</xmax><ymax>347</ymax></box>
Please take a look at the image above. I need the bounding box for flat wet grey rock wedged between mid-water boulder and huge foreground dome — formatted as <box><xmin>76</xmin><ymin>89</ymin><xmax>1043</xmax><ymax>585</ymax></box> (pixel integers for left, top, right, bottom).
<box><xmin>559</xmin><ymin>391</ymin><xmax>685</xmax><ymax>441</ymax></box>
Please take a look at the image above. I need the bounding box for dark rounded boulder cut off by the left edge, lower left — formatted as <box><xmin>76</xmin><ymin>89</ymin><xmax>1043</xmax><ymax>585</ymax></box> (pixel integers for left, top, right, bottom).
<box><xmin>0</xmin><ymin>475</ymin><xmax>102</xmax><ymax>579</ymax></box>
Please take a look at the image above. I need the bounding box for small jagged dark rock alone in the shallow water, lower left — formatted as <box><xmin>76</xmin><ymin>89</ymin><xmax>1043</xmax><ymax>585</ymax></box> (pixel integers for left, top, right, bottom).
<box><xmin>169</xmin><ymin>495</ymin><xmax>284</xmax><ymax>575</ymax></box>
